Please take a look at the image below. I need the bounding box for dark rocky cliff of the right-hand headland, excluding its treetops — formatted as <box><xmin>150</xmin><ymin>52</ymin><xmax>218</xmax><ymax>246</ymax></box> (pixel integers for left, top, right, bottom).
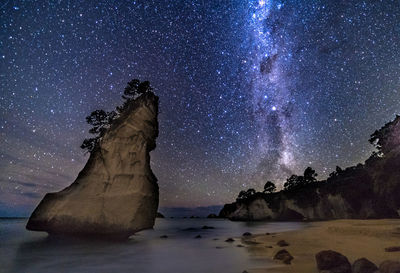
<box><xmin>219</xmin><ymin>148</ymin><xmax>400</xmax><ymax>221</ymax></box>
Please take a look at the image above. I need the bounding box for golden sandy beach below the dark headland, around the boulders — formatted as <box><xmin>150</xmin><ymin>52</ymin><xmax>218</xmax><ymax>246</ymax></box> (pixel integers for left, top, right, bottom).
<box><xmin>242</xmin><ymin>219</ymin><xmax>400</xmax><ymax>273</ymax></box>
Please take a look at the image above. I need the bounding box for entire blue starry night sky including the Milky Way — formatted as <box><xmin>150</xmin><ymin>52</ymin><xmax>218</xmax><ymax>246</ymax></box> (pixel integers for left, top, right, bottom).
<box><xmin>0</xmin><ymin>0</ymin><xmax>400</xmax><ymax>214</ymax></box>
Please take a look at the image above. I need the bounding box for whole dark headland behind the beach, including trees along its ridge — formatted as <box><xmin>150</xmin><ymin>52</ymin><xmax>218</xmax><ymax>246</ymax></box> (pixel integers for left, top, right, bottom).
<box><xmin>219</xmin><ymin>116</ymin><xmax>400</xmax><ymax>221</ymax></box>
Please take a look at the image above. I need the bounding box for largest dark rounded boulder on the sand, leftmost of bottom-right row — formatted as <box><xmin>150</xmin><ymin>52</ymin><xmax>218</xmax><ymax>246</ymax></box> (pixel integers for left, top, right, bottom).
<box><xmin>315</xmin><ymin>250</ymin><xmax>351</xmax><ymax>273</ymax></box>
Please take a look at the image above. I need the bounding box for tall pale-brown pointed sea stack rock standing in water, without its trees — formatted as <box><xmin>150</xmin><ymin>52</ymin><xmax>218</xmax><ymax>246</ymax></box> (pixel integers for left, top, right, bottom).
<box><xmin>26</xmin><ymin>92</ymin><xmax>158</xmax><ymax>237</ymax></box>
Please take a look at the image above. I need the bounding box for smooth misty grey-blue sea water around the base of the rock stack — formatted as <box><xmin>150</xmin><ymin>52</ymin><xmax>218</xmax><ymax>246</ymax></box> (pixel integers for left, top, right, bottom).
<box><xmin>0</xmin><ymin>219</ymin><xmax>306</xmax><ymax>273</ymax></box>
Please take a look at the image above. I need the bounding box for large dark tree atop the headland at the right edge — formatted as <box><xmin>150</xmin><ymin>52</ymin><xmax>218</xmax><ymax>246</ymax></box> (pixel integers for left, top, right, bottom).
<box><xmin>369</xmin><ymin>115</ymin><xmax>400</xmax><ymax>156</ymax></box>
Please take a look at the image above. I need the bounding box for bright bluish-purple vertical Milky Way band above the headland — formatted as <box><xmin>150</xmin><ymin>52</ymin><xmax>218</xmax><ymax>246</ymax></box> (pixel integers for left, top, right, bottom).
<box><xmin>249</xmin><ymin>1</ymin><xmax>296</xmax><ymax>181</ymax></box>
